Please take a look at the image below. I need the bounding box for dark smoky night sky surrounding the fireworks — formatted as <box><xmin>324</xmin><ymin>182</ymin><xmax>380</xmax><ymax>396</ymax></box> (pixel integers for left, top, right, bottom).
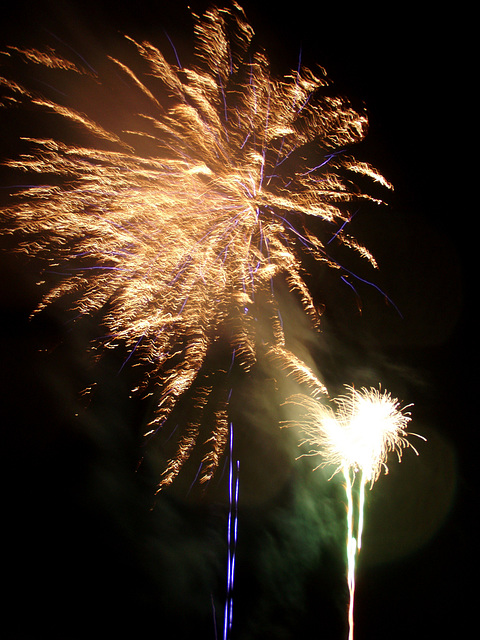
<box><xmin>0</xmin><ymin>0</ymin><xmax>472</xmax><ymax>640</ymax></box>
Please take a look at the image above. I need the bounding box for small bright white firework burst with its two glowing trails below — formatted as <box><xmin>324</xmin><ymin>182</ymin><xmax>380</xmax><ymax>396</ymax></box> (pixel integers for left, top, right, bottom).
<box><xmin>286</xmin><ymin>386</ymin><xmax>423</xmax><ymax>640</ymax></box>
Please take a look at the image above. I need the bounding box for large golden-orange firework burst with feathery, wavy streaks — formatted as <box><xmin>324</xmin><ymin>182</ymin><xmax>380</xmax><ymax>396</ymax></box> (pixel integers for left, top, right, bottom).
<box><xmin>0</xmin><ymin>3</ymin><xmax>389</xmax><ymax>488</ymax></box>
